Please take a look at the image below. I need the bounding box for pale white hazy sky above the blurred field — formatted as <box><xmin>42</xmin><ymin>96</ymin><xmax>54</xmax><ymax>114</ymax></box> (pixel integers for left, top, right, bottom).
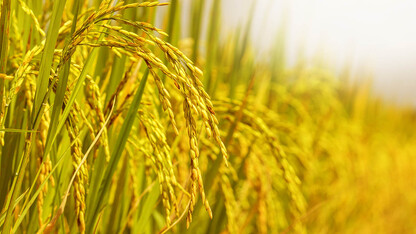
<box><xmin>222</xmin><ymin>0</ymin><xmax>416</xmax><ymax>106</ymax></box>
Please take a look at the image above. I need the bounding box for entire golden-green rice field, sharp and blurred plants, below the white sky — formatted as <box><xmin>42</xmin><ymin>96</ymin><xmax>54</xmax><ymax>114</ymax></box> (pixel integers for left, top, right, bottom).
<box><xmin>0</xmin><ymin>0</ymin><xmax>416</xmax><ymax>233</ymax></box>
